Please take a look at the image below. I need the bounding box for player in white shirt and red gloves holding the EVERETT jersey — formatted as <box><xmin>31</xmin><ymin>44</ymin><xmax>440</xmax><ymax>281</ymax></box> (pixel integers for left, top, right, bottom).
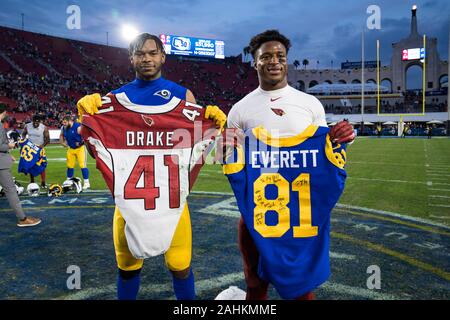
<box><xmin>228</xmin><ymin>30</ymin><xmax>355</xmax><ymax>300</ymax></box>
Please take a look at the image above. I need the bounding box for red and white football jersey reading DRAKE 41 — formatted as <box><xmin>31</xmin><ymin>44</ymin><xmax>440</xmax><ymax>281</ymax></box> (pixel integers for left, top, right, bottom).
<box><xmin>81</xmin><ymin>93</ymin><xmax>219</xmax><ymax>258</ymax></box>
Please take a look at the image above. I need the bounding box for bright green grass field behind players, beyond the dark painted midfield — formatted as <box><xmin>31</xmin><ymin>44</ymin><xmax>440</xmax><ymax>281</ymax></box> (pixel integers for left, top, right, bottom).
<box><xmin>13</xmin><ymin>137</ymin><xmax>450</xmax><ymax>225</ymax></box>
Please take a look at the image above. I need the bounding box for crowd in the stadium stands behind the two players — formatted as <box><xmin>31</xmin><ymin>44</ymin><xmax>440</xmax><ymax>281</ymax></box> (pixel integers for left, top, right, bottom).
<box><xmin>0</xmin><ymin>27</ymin><xmax>447</xmax><ymax>128</ymax></box>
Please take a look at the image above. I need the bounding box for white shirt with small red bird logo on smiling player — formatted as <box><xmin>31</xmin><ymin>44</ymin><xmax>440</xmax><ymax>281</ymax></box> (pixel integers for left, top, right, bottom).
<box><xmin>228</xmin><ymin>86</ymin><xmax>327</xmax><ymax>137</ymax></box>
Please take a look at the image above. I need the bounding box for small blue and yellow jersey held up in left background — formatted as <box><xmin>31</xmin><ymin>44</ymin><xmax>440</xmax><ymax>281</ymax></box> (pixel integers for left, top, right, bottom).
<box><xmin>18</xmin><ymin>139</ymin><xmax>47</xmax><ymax>177</ymax></box>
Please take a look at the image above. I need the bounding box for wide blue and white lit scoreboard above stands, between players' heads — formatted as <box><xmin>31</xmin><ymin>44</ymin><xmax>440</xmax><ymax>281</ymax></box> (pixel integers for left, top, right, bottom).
<box><xmin>159</xmin><ymin>34</ymin><xmax>225</xmax><ymax>59</ymax></box>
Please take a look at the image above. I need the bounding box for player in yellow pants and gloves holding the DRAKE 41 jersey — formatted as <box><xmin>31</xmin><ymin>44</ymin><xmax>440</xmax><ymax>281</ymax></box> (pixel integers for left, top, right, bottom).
<box><xmin>77</xmin><ymin>33</ymin><xmax>226</xmax><ymax>300</ymax></box>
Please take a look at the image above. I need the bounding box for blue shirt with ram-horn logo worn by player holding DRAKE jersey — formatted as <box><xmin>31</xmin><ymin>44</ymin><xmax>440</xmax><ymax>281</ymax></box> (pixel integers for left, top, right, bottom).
<box><xmin>111</xmin><ymin>77</ymin><xmax>187</xmax><ymax>106</ymax></box>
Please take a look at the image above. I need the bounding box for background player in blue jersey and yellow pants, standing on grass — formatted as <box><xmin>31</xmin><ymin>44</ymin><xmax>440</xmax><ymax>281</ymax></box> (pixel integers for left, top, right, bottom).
<box><xmin>59</xmin><ymin>116</ymin><xmax>91</xmax><ymax>190</ymax></box>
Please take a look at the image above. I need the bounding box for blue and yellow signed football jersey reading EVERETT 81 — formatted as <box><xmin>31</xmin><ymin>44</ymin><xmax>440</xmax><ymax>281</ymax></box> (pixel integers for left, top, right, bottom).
<box><xmin>223</xmin><ymin>125</ymin><xmax>346</xmax><ymax>299</ymax></box>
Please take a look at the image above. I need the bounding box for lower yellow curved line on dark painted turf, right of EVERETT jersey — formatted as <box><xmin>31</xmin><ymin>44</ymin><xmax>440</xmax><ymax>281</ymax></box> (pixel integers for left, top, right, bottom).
<box><xmin>330</xmin><ymin>231</ymin><xmax>450</xmax><ymax>281</ymax></box>
